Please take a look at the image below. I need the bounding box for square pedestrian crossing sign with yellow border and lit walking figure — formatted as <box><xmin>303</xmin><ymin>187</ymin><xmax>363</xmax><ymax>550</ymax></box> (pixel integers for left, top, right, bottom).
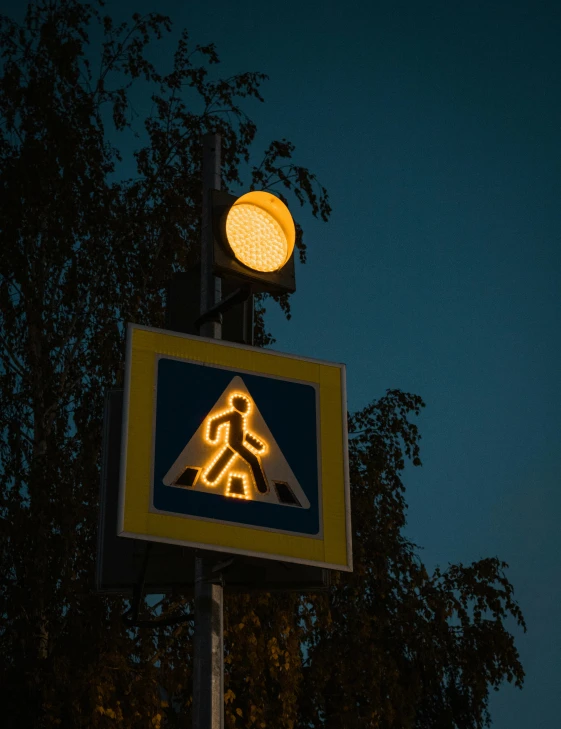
<box><xmin>118</xmin><ymin>325</ymin><xmax>352</xmax><ymax>570</ymax></box>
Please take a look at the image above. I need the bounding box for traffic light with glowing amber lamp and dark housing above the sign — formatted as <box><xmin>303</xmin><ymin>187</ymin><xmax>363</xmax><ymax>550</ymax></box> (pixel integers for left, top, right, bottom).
<box><xmin>212</xmin><ymin>190</ymin><xmax>296</xmax><ymax>294</ymax></box>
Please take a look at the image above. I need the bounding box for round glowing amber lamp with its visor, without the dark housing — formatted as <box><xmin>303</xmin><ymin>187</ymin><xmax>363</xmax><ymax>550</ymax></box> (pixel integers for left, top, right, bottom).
<box><xmin>226</xmin><ymin>191</ymin><xmax>296</xmax><ymax>272</ymax></box>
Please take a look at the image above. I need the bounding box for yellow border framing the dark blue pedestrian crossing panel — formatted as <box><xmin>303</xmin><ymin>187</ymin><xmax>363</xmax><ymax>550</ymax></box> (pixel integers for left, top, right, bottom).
<box><xmin>117</xmin><ymin>324</ymin><xmax>352</xmax><ymax>571</ymax></box>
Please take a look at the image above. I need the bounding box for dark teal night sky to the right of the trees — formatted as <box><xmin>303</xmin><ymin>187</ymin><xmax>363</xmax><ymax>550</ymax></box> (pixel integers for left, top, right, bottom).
<box><xmin>5</xmin><ymin>0</ymin><xmax>561</xmax><ymax>729</ymax></box>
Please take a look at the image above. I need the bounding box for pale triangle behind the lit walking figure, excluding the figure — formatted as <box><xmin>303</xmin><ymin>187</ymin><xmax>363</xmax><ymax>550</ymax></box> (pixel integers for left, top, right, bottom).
<box><xmin>162</xmin><ymin>375</ymin><xmax>310</xmax><ymax>509</ymax></box>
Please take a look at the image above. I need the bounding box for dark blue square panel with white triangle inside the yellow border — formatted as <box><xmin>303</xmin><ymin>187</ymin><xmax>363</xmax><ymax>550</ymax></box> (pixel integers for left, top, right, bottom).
<box><xmin>151</xmin><ymin>355</ymin><xmax>322</xmax><ymax>538</ymax></box>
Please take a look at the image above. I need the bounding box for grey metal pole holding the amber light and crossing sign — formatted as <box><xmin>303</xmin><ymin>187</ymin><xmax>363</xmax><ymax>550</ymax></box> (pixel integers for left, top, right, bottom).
<box><xmin>193</xmin><ymin>134</ymin><xmax>224</xmax><ymax>729</ymax></box>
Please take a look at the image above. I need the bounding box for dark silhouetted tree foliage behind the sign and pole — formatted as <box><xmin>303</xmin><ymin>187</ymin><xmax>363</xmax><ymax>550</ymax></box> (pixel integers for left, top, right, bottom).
<box><xmin>0</xmin><ymin>0</ymin><xmax>524</xmax><ymax>729</ymax></box>
